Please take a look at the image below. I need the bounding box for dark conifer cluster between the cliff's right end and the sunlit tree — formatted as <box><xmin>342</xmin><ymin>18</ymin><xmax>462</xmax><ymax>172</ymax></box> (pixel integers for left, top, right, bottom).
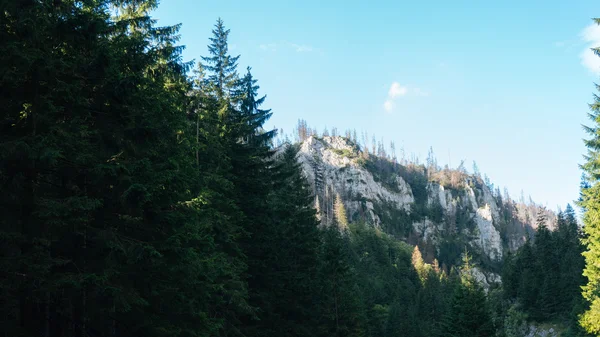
<box><xmin>502</xmin><ymin>205</ymin><xmax>585</xmax><ymax>321</ymax></box>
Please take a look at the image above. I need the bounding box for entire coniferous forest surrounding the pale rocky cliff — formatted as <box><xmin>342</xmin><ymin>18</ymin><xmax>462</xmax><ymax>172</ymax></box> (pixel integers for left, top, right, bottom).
<box><xmin>0</xmin><ymin>0</ymin><xmax>600</xmax><ymax>337</ymax></box>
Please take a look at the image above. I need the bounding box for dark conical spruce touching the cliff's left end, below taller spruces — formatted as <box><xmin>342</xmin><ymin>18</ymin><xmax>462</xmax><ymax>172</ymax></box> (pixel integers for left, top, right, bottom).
<box><xmin>244</xmin><ymin>145</ymin><xmax>320</xmax><ymax>336</ymax></box>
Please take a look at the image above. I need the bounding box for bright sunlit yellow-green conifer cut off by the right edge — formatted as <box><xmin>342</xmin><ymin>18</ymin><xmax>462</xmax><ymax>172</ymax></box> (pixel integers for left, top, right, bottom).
<box><xmin>579</xmin><ymin>19</ymin><xmax>600</xmax><ymax>334</ymax></box>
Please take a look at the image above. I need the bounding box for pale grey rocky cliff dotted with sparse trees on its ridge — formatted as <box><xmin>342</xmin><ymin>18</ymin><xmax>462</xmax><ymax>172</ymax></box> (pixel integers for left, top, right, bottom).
<box><xmin>298</xmin><ymin>136</ymin><xmax>554</xmax><ymax>282</ymax></box>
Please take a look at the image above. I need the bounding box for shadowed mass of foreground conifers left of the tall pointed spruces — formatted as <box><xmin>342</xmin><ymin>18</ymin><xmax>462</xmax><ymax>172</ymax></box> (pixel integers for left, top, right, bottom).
<box><xmin>0</xmin><ymin>1</ymin><xmax>246</xmax><ymax>336</ymax></box>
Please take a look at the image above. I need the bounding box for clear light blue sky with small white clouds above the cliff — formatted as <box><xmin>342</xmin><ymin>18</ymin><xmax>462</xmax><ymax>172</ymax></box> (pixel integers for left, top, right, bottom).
<box><xmin>153</xmin><ymin>0</ymin><xmax>600</xmax><ymax>209</ymax></box>
